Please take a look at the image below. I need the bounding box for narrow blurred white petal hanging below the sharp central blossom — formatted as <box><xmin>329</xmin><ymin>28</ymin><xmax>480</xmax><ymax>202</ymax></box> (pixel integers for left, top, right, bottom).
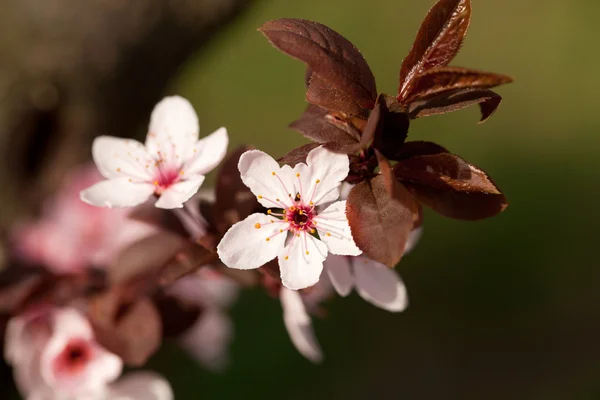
<box><xmin>279</xmin><ymin>287</ymin><xmax>323</xmax><ymax>363</ymax></box>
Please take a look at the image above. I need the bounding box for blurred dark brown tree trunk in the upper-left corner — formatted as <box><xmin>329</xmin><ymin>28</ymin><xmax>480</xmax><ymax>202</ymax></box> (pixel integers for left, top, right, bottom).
<box><xmin>0</xmin><ymin>0</ymin><xmax>252</xmax><ymax>227</ymax></box>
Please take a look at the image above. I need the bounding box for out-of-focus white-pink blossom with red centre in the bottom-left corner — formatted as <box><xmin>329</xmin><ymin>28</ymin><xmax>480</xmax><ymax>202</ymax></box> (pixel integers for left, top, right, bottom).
<box><xmin>4</xmin><ymin>308</ymin><xmax>173</xmax><ymax>400</ymax></box>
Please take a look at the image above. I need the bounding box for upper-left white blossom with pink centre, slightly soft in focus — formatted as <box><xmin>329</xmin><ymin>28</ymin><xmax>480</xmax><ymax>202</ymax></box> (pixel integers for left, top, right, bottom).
<box><xmin>81</xmin><ymin>96</ymin><xmax>229</xmax><ymax>209</ymax></box>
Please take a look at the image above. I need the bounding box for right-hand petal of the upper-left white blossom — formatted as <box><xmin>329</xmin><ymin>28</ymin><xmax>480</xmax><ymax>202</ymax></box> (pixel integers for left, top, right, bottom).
<box><xmin>183</xmin><ymin>128</ymin><xmax>229</xmax><ymax>175</ymax></box>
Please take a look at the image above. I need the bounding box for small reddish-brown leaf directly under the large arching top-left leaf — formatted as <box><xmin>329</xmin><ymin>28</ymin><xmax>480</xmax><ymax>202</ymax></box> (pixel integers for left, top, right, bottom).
<box><xmin>306</xmin><ymin>74</ymin><xmax>365</xmax><ymax>115</ymax></box>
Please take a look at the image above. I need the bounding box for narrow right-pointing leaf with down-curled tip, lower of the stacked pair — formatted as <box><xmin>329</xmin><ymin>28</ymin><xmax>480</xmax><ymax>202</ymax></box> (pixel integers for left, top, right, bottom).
<box><xmin>410</xmin><ymin>89</ymin><xmax>502</xmax><ymax>123</ymax></box>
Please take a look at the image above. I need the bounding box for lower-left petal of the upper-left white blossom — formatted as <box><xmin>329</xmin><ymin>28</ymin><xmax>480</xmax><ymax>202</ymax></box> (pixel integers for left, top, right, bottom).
<box><xmin>81</xmin><ymin>178</ymin><xmax>154</xmax><ymax>208</ymax></box>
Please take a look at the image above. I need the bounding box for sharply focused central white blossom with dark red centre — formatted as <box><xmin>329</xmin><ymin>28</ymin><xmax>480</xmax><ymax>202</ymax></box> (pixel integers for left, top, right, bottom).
<box><xmin>217</xmin><ymin>146</ymin><xmax>361</xmax><ymax>290</ymax></box>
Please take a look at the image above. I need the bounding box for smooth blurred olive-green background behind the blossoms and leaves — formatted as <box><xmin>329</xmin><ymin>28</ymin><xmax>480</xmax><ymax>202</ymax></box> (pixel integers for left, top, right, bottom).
<box><xmin>0</xmin><ymin>0</ymin><xmax>600</xmax><ymax>400</ymax></box>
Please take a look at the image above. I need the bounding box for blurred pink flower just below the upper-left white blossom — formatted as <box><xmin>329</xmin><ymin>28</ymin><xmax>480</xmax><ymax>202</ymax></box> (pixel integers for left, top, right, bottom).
<box><xmin>12</xmin><ymin>165</ymin><xmax>156</xmax><ymax>274</ymax></box>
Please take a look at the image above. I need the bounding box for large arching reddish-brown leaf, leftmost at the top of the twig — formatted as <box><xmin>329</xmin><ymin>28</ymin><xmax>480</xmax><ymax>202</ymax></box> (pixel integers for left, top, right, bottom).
<box><xmin>259</xmin><ymin>18</ymin><xmax>377</xmax><ymax>108</ymax></box>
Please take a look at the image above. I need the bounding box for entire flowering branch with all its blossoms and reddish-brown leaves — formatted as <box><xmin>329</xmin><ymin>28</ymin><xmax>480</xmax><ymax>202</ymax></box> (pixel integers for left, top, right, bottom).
<box><xmin>0</xmin><ymin>0</ymin><xmax>510</xmax><ymax>399</ymax></box>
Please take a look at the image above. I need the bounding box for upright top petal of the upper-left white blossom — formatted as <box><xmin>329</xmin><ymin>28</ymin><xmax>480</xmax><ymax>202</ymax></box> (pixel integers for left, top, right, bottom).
<box><xmin>146</xmin><ymin>96</ymin><xmax>200</xmax><ymax>165</ymax></box>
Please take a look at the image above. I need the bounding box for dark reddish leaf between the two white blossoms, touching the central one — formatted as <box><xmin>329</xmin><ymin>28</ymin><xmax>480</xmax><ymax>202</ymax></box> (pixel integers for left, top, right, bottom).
<box><xmin>212</xmin><ymin>146</ymin><xmax>260</xmax><ymax>234</ymax></box>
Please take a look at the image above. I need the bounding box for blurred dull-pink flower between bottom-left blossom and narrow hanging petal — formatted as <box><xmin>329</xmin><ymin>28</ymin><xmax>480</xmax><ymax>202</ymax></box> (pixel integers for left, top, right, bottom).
<box><xmin>169</xmin><ymin>267</ymin><xmax>239</xmax><ymax>371</ymax></box>
